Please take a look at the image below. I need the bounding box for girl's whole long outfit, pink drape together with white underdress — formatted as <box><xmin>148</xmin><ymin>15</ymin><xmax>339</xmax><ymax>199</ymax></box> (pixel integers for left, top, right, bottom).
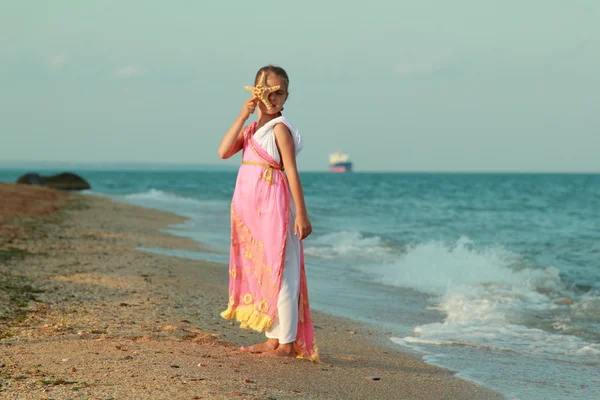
<box><xmin>221</xmin><ymin>117</ymin><xmax>318</xmax><ymax>361</ymax></box>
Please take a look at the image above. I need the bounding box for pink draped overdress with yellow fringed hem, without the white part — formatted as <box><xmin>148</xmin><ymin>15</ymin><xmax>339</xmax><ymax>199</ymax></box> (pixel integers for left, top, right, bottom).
<box><xmin>221</xmin><ymin>118</ymin><xmax>318</xmax><ymax>361</ymax></box>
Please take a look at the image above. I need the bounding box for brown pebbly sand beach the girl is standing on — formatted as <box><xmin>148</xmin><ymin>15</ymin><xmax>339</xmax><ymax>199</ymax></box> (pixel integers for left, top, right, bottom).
<box><xmin>0</xmin><ymin>183</ymin><xmax>502</xmax><ymax>400</ymax></box>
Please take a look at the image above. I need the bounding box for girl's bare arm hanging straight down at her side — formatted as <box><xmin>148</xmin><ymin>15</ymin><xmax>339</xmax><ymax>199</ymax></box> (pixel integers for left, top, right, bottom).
<box><xmin>273</xmin><ymin>124</ymin><xmax>312</xmax><ymax>240</ymax></box>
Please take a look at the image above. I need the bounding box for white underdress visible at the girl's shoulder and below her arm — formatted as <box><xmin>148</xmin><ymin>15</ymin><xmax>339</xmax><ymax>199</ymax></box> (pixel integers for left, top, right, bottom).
<box><xmin>254</xmin><ymin>117</ymin><xmax>302</xmax><ymax>344</ymax></box>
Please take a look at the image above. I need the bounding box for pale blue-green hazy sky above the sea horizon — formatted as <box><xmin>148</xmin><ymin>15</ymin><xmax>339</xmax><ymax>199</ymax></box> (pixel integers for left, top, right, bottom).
<box><xmin>0</xmin><ymin>0</ymin><xmax>600</xmax><ymax>172</ymax></box>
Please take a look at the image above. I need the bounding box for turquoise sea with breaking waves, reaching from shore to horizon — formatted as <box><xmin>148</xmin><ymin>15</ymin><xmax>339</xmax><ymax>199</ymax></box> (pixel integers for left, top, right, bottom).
<box><xmin>0</xmin><ymin>168</ymin><xmax>600</xmax><ymax>399</ymax></box>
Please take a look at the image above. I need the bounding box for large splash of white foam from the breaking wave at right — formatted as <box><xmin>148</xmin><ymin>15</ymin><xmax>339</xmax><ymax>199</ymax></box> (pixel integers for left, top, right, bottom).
<box><xmin>380</xmin><ymin>237</ymin><xmax>598</xmax><ymax>356</ymax></box>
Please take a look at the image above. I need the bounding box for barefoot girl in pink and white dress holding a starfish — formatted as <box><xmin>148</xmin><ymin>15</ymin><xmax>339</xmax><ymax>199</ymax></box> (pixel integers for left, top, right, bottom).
<box><xmin>219</xmin><ymin>65</ymin><xmax>318</xmax><ymax>361</ymax></box>
